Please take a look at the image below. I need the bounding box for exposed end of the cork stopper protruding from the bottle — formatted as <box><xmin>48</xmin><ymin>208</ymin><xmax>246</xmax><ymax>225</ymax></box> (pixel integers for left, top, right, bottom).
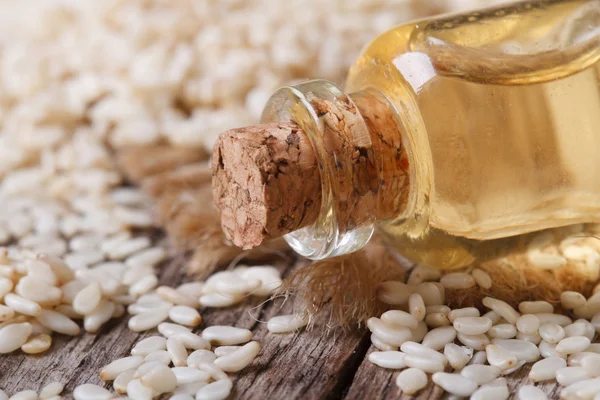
<box><xmin>212</xmin><ymin>122</ymin><xmax>321</xmax><ymax>249</ymax></box>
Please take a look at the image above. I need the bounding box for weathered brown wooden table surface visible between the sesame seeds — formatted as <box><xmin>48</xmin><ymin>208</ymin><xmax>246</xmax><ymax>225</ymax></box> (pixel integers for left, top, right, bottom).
<box><xmin>0</xmin><ymin>252</ymin><xmax>560</xmax><ymax>400</ymax></box>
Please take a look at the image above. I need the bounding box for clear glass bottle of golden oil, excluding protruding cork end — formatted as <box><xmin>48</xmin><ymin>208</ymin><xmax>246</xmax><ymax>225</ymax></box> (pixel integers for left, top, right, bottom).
<box><xmin>262</xmin><ymin>0</ymin><xmax>600</xmax><ymax>268</ymax></box>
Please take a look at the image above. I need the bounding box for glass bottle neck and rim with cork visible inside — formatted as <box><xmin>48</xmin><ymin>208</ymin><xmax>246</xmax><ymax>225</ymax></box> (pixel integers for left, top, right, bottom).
<box><xmin>262</xmin><ymin>80</ymin><xmax>411</xmax><ymax>259</ymax></box>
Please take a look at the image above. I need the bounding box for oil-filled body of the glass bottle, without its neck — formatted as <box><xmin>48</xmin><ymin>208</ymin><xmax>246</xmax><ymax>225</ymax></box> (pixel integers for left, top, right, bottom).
<box><xmin>346</xmin><ymin>1</ymin><xmax>600</xmax><ymax>268</ymax></box>
